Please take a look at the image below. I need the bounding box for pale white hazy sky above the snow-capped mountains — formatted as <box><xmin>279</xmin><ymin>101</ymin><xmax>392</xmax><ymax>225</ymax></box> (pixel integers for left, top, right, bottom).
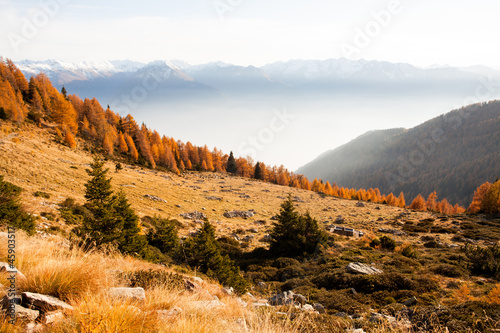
<box><xmin>0</xmin><ymin>0</ymin><xmax>500</xmax><ymax>67</ymax></box>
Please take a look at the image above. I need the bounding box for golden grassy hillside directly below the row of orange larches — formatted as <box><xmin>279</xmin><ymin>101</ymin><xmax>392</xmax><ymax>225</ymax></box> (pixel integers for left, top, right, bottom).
<box><xmin>0</xmin><ymin>123</ymin><xmax>442</xmax><ymax>247</ymax></box>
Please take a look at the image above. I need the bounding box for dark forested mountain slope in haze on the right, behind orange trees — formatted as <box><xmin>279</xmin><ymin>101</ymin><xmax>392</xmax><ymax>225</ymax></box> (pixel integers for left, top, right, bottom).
<box><xmin>297</xmin><ymin>101</ymin><xmax>500</xmax><ymax>205</ymax></box>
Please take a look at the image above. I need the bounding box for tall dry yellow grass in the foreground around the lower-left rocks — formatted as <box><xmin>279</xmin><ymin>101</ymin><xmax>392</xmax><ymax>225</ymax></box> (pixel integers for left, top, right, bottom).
<box><xmin>0</xmin><ymin>231</ymin><xmax>314</xmax><ymax>333</ymax></box>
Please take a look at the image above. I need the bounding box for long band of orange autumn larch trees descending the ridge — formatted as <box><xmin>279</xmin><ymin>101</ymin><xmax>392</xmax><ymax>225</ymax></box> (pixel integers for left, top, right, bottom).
<box><xmin>0</xmin><ymin>59</ymin><xmax>484</xmax><ymax>214</ymax></box>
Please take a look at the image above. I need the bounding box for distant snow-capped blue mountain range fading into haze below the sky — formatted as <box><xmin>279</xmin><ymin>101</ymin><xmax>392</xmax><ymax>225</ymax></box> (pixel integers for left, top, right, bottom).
<box><xmin>16</xmin><ymin>58</ymin><xmax>500</xmax><ymax>107</ymax></box>
